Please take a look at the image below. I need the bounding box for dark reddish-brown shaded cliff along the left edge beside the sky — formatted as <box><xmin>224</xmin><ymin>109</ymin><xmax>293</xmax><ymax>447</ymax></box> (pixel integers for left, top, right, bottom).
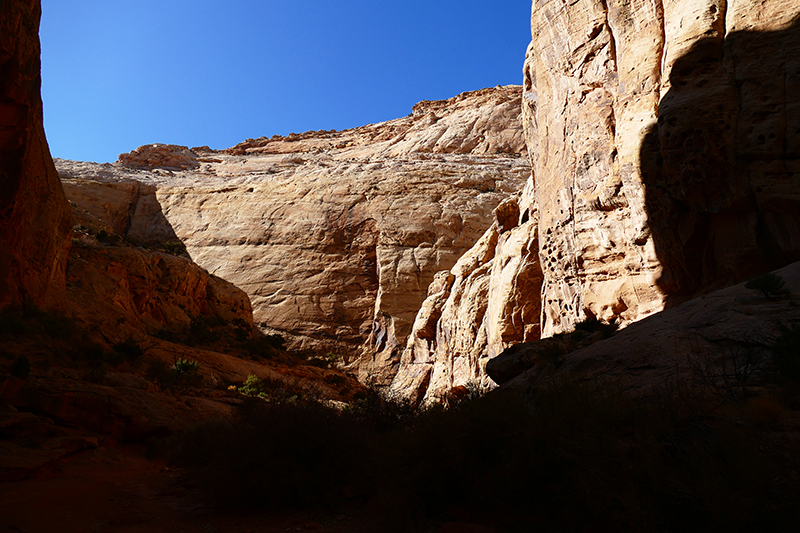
<box><xmin>0</xmin><ymin>0</ymin><xmax>71</xmax><ymax>308</ymax></box>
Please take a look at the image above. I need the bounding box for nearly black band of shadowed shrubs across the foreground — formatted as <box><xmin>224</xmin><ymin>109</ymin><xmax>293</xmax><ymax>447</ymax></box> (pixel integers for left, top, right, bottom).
<box><xmin>173</xmin><ymin>379</ymin><xmax>798</xmax><ymax>531</ymax></box>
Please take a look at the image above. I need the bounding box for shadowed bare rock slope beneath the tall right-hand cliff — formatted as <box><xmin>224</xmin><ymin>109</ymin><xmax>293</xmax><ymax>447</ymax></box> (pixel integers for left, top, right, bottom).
<box><xmin>504</xmin><ymin>263</ymin><xmax>800</xmax><ymax>395</ymax></box>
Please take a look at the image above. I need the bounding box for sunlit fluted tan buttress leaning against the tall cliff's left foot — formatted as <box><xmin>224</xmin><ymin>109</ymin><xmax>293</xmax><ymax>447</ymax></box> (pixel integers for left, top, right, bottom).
<box><xmin>390</xmin><ymin>199</ymin><xmax>541</xmax><ymax>404</ymax></box>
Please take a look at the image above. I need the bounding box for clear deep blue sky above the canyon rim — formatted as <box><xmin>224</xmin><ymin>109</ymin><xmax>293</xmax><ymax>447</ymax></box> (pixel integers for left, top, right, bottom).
<box><xmin>40</xmin><ymin>0</ymin><xmax>531</xmax><ymax>162</ymax></box>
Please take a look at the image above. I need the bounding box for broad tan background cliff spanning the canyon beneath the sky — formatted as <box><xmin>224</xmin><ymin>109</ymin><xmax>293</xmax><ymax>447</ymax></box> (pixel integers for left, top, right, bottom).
<box><xmin>57</xmin><ymin>86</ymin><xmax>530</xmax><ymax>384</ymax></box>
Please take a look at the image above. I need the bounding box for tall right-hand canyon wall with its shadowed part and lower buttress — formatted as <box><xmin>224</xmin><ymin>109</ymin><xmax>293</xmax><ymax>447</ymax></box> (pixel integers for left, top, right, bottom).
<box><xmin>392</xmin><ymin>0</ymin><xmax>800</xmax><ymax>399</ymax></box>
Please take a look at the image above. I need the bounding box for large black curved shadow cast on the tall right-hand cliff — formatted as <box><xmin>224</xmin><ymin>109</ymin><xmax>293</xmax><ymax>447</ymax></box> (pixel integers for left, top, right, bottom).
<box><xmin>640</xmin><ymin>18</ymin><xmax>800</xmax><ymax>306</ymax></box>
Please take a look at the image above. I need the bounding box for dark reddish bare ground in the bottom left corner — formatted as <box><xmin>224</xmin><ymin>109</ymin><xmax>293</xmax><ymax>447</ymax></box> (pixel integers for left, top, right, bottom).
<box><xmin>0</xmin><ymin>445</ymin><xmax>382</xmax><ymax>533</ymax></box>
